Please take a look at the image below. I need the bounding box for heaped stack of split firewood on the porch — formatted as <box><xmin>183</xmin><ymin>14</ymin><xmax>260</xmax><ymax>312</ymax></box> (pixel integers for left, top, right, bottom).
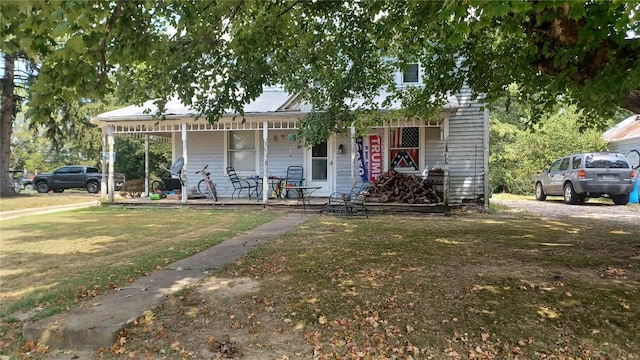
<box><xmin>367</xmin><ymin>170</ymin><xmax>441</xmax><ymax>204</ymax></box>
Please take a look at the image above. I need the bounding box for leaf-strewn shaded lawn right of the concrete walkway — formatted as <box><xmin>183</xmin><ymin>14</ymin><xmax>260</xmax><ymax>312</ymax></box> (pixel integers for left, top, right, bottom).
<box><xmin>97</xmin><ymin>214</ymin><xmax>640</xmax><ymax>359</ymax></box>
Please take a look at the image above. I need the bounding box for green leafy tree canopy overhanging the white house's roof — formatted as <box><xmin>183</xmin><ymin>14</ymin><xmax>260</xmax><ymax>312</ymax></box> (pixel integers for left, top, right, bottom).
<box><xmin>0</xmin><ymin>0</ymin><xmax>640</xmax><ymax>194</ymax></box>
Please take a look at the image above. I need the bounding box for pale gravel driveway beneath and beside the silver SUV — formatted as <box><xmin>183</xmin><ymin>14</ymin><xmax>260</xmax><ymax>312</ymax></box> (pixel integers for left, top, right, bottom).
<box><xmin>491</xmin><ymin>199</ymin><xmax>640</xmax><ymax>226</ymax></box>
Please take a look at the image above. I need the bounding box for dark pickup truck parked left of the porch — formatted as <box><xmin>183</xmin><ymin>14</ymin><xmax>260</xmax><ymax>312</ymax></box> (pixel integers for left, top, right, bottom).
<box><xmin>32</xmin><ymin>165</ymin><xmax>125</xmax><ymax>194</ymax></box>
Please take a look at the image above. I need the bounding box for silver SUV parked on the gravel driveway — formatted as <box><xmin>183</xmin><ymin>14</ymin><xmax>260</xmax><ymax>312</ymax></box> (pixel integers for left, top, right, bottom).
<box><xmin>536</xmin><ymin>152</ymin><xmax>634</xmax><ymax>205</ymax></box>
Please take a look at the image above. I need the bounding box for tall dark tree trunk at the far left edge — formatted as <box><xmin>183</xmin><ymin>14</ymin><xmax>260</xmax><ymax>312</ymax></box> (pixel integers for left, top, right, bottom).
<box><xmin>0</xmin><ymin>53</ymin><xmax>15</xmax><ymax>197</ymax></box>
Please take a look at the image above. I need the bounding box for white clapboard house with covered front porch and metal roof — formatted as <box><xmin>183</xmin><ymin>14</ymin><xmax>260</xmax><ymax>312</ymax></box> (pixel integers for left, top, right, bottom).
<box><xmin>92</xmin><ymin>65</ymin><xmax>489</xmax><ymax>205</ymax></box>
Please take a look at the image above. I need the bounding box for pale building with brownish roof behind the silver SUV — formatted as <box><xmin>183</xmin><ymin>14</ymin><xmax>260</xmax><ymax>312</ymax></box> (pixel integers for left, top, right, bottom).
<box><xmin>602</xmin><ymin>114</ymin><xmax>640</xmax><ymax>173</ymax></box>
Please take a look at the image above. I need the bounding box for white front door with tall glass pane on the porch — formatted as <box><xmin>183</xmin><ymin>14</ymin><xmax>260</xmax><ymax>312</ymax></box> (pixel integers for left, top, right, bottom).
<box><xmin>304</xmin><ymin>141</ymin><xmax>333</xmax><ymax>197</ymax></box>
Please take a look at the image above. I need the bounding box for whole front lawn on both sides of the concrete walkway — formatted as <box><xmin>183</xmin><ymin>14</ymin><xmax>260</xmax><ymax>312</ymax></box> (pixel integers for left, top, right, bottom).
<box><xmin>0</xmin><ymin>204</ymin><xmax>640</xmax><ymax>359</ymax></box>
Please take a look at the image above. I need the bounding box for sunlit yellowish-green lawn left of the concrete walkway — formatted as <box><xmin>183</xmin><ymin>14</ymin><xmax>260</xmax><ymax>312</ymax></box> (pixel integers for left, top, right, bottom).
<box><xmin>0</xmin><ymin>207</ymin><xmax>278</xmax><ymax>321</ymax></box>
